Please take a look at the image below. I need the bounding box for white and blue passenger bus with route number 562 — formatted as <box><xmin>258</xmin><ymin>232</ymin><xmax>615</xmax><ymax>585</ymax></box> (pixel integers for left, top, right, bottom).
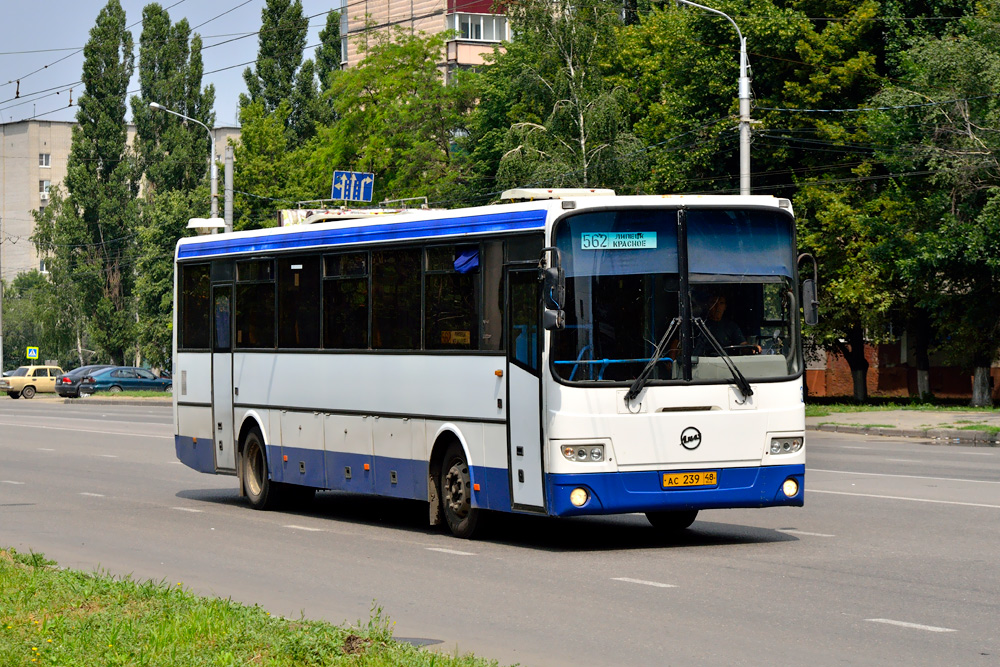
<box><xmin>173</xmin><ymin>190</ymin><xmax>815</xmax><ymax>538</ymax></box>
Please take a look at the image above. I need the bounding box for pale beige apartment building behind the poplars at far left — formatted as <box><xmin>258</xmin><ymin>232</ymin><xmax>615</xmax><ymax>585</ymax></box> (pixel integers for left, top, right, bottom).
<box><xmin>0</xmin><ymin>120</ymin><xmax>240</xmax><ymax>283</ymax></box>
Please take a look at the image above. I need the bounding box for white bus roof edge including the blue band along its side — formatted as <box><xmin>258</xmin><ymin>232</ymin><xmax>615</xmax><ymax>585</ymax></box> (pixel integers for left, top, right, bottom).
<box><xmin>176</xmin><ymin>195</ymin><xmax>791</xmax><ymax>260</ymax></box>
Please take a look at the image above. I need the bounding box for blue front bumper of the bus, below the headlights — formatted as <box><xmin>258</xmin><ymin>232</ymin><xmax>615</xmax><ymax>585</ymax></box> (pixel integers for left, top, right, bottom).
<box><xmin>546</xmin><ymin>465</ymin><xmax>805</xmax><ymax>516</ymax></box>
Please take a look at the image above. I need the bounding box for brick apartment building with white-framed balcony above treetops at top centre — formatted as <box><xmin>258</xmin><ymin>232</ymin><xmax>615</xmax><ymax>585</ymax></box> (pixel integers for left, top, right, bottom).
<box><xmin>340</xmin><ymin>0</ymin><xmax>510</xmax><ymax>67</ymax></box>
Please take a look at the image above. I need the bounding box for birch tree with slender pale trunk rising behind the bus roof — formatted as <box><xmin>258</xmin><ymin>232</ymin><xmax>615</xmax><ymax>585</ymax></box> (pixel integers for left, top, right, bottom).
<box><xmin>487</xmin><ymin>0</ymin><xmax>645</xmax><ymax>187</ymax></box>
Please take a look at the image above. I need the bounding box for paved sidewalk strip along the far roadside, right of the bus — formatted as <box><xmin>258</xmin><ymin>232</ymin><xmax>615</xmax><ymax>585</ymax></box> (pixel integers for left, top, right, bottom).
<box><xmin>806</xmin><ymin>410</ymin><xmax>1000</xmax><ymax>447</ymax></box>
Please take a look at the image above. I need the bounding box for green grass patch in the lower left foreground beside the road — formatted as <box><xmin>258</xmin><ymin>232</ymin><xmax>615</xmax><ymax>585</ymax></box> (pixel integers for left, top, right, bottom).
<box><xmin>0</xmin><ymin>549</ymin><xmax>496</xmax><ymax>667</ymax></box>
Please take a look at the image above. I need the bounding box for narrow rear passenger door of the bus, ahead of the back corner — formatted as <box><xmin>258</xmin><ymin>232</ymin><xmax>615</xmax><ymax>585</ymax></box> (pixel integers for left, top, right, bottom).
<box><xmin>212</xmin><ymin>284</ymin><xmax>236</xmax><ymax>471</ymax></box>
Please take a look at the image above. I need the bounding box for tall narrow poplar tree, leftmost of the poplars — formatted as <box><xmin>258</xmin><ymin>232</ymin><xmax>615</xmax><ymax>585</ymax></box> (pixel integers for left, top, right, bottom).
<box><xmin>33</xmin><ymin>0</ymin><xmax>138</xmax><ymax>363</ymax></box>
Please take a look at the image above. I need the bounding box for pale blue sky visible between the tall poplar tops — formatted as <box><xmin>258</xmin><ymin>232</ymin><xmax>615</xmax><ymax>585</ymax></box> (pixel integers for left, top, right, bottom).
<box><xmin>0</xmin><ymin>0</ymin><xmax>340</xmax><ymax>126</ymax></box>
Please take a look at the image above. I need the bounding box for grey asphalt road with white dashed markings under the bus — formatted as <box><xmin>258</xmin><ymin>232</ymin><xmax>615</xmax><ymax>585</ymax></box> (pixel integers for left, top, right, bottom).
<box><xmin>0</xmin><ymin>398</ymin><xmax>1000</xmax><ymax>666</ymax></box>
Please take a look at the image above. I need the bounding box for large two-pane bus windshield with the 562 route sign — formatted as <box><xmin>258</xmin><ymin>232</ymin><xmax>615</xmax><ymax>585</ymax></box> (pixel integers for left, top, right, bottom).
<box><xmin>551</xmin><ymin>209</ymin><xmax>802</xmax><ymax>384</ymax></box>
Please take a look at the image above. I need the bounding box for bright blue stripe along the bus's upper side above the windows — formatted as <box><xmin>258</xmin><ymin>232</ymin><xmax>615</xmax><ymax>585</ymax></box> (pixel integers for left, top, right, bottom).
<box><xmin>177</xmin><ymin>210</ymin><xmax>546</xmax><ymax>259</ymax></box>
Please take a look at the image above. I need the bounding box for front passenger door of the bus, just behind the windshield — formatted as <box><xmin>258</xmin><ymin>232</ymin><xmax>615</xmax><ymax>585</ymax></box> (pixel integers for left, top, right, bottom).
<box><xmin>506</xmin><ymin>268</ymin><xmax>545</xmax><ymax>512</ymax></box>
